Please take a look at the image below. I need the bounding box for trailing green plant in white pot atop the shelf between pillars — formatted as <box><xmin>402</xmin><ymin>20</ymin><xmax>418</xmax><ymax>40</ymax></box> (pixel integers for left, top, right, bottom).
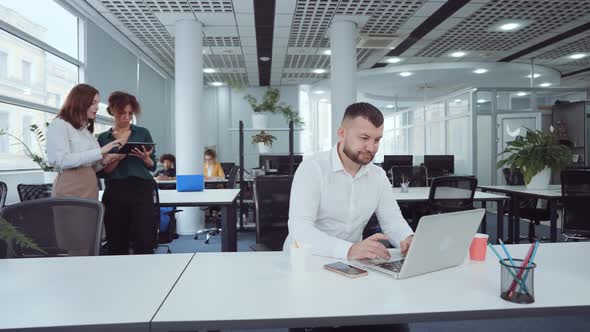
<box><xmin>244</xmin><ymin>88</ymin><xmax>303</xmax><ymax>129</ymax></box>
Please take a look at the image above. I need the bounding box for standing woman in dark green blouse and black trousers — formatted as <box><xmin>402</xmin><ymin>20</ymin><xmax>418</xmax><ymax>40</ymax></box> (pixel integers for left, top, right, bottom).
<box><xmin>98</xmin><ymin>91</ymin><xmax>156</xmax><ymax>255</ymax></box>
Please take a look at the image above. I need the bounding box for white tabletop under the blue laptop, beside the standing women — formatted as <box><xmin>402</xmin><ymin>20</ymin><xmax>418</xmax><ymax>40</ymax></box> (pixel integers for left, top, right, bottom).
<box><xmin>98</xmin><ymin>189</ymin><xmax>240</xmax><ymax>206</ymax></box>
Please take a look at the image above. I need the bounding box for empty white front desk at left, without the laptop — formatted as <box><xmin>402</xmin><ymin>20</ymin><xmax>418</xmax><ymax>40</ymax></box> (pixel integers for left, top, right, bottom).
<box><xmin>0</xmin><ymin>254</ymin><xmax>194</xmax><ymax>331</ymax></box>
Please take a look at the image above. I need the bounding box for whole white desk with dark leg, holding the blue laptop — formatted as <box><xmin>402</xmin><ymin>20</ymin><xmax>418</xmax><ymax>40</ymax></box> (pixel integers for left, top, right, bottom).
<box><xmin>98</xmin><ymin>189</ymin><xmax>240</xmax><ymax>251</ymax></box>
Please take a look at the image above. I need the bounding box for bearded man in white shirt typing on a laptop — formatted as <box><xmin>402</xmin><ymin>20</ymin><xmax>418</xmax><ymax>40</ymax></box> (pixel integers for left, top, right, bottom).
<box><xmin>283</xmin><ymin>103</ymin><xmax>414</xmax><ymax>260</ymax></box>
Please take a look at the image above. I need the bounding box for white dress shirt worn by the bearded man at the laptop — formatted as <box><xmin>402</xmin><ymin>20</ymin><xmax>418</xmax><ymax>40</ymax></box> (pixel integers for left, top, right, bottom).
<box><xmin>283</xmin><ymin>145</ymin><xmax>414</xmax><ymax>259</ymax></box>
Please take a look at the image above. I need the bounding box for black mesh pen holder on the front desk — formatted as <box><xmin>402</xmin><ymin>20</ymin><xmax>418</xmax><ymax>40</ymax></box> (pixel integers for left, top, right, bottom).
<box><xmin>500</xmin><ymin>259</ymin><xmax>537</xmax><ymax>303</ymax></box>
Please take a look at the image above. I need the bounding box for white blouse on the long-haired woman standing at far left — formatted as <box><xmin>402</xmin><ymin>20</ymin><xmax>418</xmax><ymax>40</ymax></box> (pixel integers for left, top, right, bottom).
<box><xmin>47</xmin><ymin>118</ymin><xmax>102</xmax><ymax>171</ymax></box>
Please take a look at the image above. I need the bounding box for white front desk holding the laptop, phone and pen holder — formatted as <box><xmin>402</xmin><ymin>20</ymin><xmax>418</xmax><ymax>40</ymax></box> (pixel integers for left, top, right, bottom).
<box><xmin>151</xmin><ymin>242</ymin><xmax>590</xmax><ymax>331</ymax></box>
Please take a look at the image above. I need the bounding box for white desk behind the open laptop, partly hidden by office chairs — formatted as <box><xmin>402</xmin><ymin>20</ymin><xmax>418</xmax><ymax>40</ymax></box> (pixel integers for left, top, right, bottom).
<box><xmin>393</xmin><ymin>187</ymin><xmax>509</xmax><ymax>241</ymax></box>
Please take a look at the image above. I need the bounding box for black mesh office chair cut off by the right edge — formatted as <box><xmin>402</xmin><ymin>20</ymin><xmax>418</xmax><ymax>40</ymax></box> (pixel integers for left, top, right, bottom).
<box><xmin>561</xmin><ymin>169</ymin><xmax>590</xmax><ymax>242</ymax></box>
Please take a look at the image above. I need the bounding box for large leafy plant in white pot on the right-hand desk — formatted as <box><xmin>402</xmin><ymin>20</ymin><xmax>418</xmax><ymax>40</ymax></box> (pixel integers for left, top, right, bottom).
<box><xmin>497</xmin><ymin>128</ymin><xmax>572</xmax><ymax>189</ymax></box>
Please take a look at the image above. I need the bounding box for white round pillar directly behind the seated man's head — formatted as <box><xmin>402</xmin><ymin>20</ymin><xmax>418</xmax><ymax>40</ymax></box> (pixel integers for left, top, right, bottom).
<box><xmin>330</xmin><ymin>21</ymin><xmax>357</xmax><ymax>145</ymax></box>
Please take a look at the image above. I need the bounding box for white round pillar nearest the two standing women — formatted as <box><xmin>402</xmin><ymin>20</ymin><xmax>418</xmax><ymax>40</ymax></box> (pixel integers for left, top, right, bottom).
<box><xmin>174</xmin><ymin>19</ymin><xmax>204</xmax><ymax>235</ymax></box>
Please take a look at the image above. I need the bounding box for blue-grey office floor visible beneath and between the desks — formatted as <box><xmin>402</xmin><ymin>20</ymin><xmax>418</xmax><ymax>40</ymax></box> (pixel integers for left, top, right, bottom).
<box><xmin>158</xmin><ymin>213</ymin><xmax>590</xmax><ymax>332</ymax></box>
